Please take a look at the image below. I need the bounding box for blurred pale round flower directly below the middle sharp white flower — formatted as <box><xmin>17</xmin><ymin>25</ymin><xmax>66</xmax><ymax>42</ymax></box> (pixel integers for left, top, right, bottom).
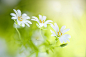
<box><xmin>31</xmin><ymin>30</ymin><xmax>44</xmax><ymax>45</ymax></box>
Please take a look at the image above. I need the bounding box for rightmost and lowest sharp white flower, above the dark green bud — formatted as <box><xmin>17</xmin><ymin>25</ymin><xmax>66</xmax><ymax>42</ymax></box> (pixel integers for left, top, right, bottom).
<box><xmin>50</xmin><ymin>23</ymin><xmax>71</xmax><ymax>43</ymax></box>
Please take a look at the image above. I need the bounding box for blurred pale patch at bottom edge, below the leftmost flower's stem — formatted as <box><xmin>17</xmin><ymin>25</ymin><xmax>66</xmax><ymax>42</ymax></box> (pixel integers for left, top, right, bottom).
<box><xmin>16</xmin><ymin>46</ymin><xmax>31</xmax><ymax>57</ymax></box>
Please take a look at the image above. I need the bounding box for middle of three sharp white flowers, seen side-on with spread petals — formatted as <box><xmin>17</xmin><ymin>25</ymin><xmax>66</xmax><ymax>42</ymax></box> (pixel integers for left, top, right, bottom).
<box><xmin>31</xmin><ymin>15</ymin><xmax>53</xmax><ymax>27</ymax></box>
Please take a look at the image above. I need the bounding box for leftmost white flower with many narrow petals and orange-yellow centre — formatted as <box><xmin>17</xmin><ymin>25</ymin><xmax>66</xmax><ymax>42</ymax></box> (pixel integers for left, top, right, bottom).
<box><xmin>11</xmin><ymin>9</ymin><xmax>32</xmax><ymax>27</ymax></box>
